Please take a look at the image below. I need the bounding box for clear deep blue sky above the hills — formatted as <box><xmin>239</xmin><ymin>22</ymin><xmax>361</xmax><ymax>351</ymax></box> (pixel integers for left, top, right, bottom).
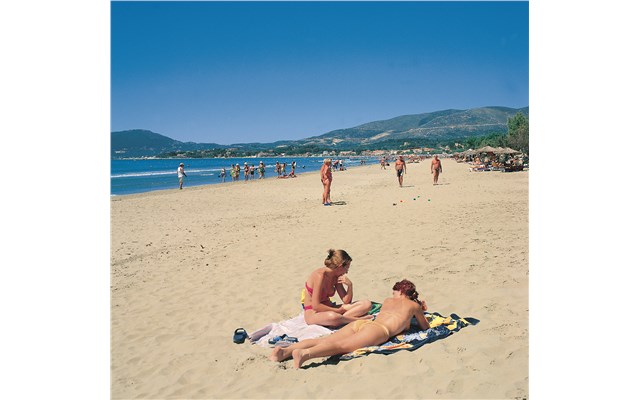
<box><xmin>111</xmin><ymin>2</ymin><xmax>529</xmax><ymax>144</ymax></box>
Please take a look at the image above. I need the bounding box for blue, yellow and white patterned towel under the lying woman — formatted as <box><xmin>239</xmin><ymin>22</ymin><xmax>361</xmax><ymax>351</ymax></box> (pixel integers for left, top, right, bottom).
<box><xmin>336</xmin><ymin>312</ymin><xmax>480</xmax><ymax>360</ymax></box>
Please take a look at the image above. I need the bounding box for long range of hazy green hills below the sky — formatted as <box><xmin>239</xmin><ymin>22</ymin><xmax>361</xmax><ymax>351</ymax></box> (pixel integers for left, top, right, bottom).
<box><xmin>111</xmin><ymin>107</ymin><xmax>529</xmax><ymax>158</ymax></box>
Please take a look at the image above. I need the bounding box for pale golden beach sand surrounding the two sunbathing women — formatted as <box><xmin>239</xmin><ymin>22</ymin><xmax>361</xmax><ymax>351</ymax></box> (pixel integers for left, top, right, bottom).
<box><xmin>111</xmin><ymin>159</ymin><xmax>529</xmax><ymax>399</ymax></box>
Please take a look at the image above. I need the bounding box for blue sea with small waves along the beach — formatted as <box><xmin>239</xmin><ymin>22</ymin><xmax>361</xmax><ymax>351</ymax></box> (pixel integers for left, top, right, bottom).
<box><xmin>111</xmin><ymin>157</ymin><xmax>374</xmax><ymax>195</ymax></box>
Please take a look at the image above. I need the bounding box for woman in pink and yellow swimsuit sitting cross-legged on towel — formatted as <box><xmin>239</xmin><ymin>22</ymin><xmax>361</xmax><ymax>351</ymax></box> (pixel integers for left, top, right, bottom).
<box><xmin>301</xmin><ymin>249</ymin><xmax>373</xmax><ymax>326</ymax></box>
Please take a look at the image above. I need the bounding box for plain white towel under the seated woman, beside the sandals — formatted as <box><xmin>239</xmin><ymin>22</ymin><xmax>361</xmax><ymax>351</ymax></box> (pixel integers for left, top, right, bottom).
<box><xmin>249</xmin><ymin>312</ymin><xmax>333</xmax><ymax>347</ymax></box>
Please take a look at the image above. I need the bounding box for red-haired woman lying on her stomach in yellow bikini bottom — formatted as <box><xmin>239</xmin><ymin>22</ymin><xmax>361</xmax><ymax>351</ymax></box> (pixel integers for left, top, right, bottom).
<box><xmin>269</xmin><ymin>279</ymin><xmax>430</xmax><ymax>368</ymax></box>
